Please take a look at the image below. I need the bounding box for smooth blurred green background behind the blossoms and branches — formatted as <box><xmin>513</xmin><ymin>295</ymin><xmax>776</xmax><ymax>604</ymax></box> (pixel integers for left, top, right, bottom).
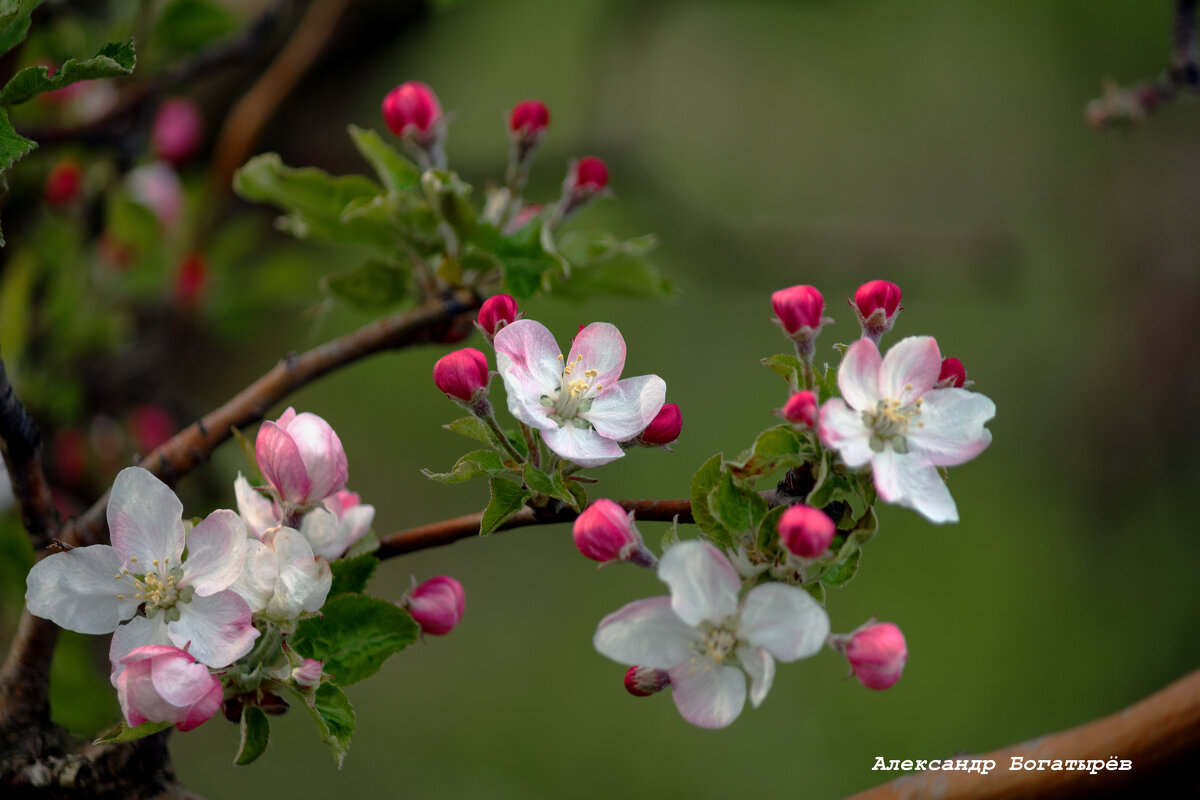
<box><xmin>9</xmin><ymin>0</ymin><xmax>1200</xmax><ymax>798</ymax></box>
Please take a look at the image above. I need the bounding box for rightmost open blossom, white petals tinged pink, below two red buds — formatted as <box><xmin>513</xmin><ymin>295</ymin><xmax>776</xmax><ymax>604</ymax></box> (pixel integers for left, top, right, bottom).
<box><xmin>821</xmin><ymin>336</ymin><xmax>996</xmax><ymax>523</ymax></box>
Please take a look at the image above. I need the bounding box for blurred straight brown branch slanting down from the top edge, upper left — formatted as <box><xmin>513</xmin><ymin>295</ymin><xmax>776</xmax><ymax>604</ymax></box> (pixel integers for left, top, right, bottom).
<box><xmin>209</xmin><ymin>0</ymin><xmax>350</xmax><ymax>198</ymax></box>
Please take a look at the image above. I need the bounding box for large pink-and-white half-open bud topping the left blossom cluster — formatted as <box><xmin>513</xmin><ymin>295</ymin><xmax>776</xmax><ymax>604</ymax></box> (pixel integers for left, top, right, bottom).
<box><xmin>254</xmin><ymin>408</ymin><xmax>349</xmax><ymax>507</ymax></box>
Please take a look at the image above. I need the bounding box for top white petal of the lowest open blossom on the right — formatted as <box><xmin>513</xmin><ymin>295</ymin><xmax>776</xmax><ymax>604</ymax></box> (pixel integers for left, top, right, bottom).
<box><xmin>659</xmin><ymin>539</ymin><xmax>742</xmax><ymax>627</ymax></box>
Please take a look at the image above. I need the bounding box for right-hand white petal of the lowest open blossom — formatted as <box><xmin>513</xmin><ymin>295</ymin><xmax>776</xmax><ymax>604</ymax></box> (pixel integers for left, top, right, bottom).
<box><xmin>738</xmin><ymin>583</ymin><xmax>829</xmax><ymax>663</ymax></box>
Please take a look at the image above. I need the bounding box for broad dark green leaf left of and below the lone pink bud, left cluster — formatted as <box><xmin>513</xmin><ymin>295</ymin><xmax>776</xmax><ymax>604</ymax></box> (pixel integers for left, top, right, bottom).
<box><xmin>292</xmin><ymin>595</ymin><xmax>418</xmax><ymax>686</ymax></box>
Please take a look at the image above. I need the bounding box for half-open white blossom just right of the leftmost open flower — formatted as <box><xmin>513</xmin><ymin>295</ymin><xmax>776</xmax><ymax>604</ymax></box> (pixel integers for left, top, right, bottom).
<box><xmin>232</xmin><ymin>525</ymin><xmax>334</xmax><ymax>625</ymax></box>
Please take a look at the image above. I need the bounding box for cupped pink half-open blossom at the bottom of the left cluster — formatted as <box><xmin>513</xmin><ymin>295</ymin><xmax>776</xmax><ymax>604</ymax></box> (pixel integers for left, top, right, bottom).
<box><xmin>116</xmin><ymin>644</ymin><xmax>222</xmax><ymax>732</ymax></box>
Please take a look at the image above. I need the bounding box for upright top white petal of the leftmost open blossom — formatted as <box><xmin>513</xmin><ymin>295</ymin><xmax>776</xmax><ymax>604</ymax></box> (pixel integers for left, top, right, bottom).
<box><xmin>108</xmin><ymin>467</ymin><xmax>184</xmax><ymax>575</ymax></box>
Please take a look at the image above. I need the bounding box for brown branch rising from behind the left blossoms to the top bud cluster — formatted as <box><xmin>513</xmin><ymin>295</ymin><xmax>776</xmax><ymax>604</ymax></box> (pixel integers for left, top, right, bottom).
<box><xmin>60</xmin><ymin>289</ymin><xmax>481</xmax><ymax>547</ymax></box>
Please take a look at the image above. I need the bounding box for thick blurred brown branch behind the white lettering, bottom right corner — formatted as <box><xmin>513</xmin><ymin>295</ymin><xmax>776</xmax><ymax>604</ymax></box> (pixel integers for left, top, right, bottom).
<box><xmin>847</xmin><ymin>670</ymin><xmax>1200</xmax><ymax>800</ymax></box>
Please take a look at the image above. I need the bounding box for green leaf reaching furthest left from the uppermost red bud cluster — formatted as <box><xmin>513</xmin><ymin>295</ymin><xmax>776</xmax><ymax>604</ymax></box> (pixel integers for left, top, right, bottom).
<box><xmin>233</xmin><ymin>152</ymin><xmax>388</xmax><ymax>248</ymax></box>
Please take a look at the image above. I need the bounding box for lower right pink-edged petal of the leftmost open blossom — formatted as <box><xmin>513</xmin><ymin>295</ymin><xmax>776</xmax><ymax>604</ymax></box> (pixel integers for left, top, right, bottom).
<box><xmin>167</xmin><ymin>590</ymin><xmax>258</xmax><ymax>667</ymax></box>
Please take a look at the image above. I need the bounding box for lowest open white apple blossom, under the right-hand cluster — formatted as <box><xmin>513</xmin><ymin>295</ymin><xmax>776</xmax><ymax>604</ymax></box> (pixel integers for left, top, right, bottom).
<box><xmin>593</xmin><ymin>540</ymin><xmax>829</xmax><ymax>728</ymax></box>
